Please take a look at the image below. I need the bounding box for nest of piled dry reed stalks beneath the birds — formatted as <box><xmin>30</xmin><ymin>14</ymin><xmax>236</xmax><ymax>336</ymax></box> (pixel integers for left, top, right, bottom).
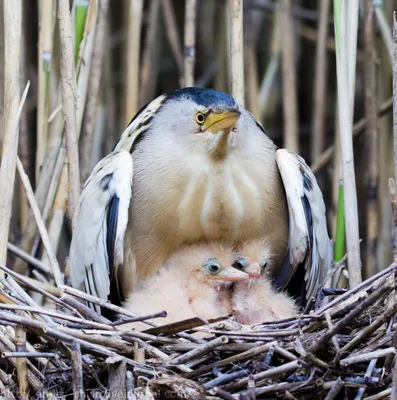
<box><xmin>0</xmin><ymin>264</ymin><xmax>397</xmax><ymax>400</ymax></box>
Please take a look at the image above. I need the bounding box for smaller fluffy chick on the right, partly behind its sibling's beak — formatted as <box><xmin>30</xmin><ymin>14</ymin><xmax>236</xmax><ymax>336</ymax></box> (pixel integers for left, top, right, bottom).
<box><xmin>232</xmin><ymin>240</ymin><xmax>298</xmax><ymax>325</ymax></box>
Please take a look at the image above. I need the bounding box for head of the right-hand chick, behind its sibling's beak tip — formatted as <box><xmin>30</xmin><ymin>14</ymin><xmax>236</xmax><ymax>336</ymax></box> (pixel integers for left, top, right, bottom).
<box><xmin>233</xmin><ymin>240</ymin><xmax>272</xmax><ymax>278</ymax></box>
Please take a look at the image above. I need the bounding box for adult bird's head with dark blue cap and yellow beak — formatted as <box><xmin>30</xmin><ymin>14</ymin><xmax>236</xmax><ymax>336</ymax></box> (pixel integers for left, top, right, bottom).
<box><xmin>155</xmin><ymin>88</ymin><xmax>241</xmax><ymax>159</ymax></box>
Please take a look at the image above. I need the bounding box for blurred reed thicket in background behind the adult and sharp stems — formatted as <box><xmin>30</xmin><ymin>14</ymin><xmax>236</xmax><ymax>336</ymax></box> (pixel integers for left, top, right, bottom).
<box><xmin>0</xmin><ymin>0</ymin><xmax>396</xmax><ymax>286</ymax></box>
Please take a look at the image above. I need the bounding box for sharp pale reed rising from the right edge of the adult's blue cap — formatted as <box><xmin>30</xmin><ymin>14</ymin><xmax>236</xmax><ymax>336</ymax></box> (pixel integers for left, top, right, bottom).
<box><xmin>229</xmin><ymin>0</ymin><xmax>245</xmax><ymax>106</ymax></box>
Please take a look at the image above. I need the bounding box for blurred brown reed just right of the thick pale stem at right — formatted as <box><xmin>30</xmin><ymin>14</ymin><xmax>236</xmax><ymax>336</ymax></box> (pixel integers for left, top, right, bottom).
<box><xmin>364</xmin><ymin>0</ymin><xmax>379</xmax><ymax>277</ymax></box>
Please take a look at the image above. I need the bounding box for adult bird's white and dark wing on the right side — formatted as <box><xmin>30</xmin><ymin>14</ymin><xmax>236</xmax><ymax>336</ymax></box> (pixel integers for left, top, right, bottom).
<box><xmin>276</xmin><ymin>149</ymin><xmax>332</xmax><ymax>299</ymax></box>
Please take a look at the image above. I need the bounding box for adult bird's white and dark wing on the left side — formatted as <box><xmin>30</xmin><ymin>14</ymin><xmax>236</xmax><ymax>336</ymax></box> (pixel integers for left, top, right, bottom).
<box><xmin>70</xmin><ymin>151</ymin><xmax>133</xmax><ymax>300</ymax></box>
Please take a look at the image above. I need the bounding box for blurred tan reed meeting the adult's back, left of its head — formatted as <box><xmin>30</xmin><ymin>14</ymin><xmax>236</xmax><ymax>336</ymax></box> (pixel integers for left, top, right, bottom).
<box><xmin>124</xmin><ymin>0</ymin><xmax>143</xmax><ymax>125</ymax></box>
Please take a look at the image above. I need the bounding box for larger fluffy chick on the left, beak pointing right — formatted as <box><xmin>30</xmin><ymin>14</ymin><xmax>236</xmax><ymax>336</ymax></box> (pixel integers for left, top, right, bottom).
<box><xmin>122</xmin><ymin>243</ymin><xmax>249</xmax><ymax>330</ymax></box>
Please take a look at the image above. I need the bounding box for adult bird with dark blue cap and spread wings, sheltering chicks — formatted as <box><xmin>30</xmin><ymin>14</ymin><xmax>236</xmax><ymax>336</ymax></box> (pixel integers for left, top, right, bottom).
<box><xmin>70</xmin><ymin>87</ymin><xmax>331</xmax><ymax>301</ymax></box>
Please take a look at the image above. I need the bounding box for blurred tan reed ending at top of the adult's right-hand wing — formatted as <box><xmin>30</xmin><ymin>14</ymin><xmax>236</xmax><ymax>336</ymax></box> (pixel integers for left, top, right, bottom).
<box><xmin>281</xmin><ymin>0</ymin><xmax>299</xmax><ymax>153</ymax></box>
